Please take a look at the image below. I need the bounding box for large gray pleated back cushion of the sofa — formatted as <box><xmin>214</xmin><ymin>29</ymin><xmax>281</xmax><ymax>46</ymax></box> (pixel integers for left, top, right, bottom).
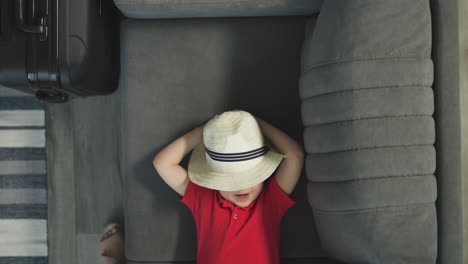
<box><xmin>299</xmin><ymin>0</ymin><xmax>437</xmax><ymax>264</ymax></box>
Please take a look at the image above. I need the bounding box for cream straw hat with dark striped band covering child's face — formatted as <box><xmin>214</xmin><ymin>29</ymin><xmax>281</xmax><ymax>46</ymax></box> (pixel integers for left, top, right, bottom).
<box><xmin>188</xmin><ymin>110</ymin><xmax>286</xmax><ymax>191</ymax></box>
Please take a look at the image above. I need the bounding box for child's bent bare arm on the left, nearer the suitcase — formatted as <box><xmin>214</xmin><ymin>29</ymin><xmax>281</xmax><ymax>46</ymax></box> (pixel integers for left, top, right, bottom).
<box><xmin>153</xmin><ymin>125</ymin><xmax>205</xmax><ymax>196</ymax></box>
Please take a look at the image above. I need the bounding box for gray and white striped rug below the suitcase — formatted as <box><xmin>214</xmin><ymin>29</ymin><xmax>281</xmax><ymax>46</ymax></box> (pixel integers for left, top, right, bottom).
<box><xmin>0</xmin><ymin>86</ymin><xmax>48</xmax><ymax>264</ymax></box>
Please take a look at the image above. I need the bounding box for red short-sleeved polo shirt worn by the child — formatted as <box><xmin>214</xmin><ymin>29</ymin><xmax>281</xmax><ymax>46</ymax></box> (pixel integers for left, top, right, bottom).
<box><xmin>180</xmin><ymin>177</ymin><xmax>297</xmax><ymax>264</ymax></box>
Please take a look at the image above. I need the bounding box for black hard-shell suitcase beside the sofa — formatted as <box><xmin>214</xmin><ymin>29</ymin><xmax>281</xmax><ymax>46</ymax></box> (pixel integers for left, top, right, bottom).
<box><xmin>0</xmin><ymin>0</ymin><xmax>123</xmax><ymax>102</ymax></box>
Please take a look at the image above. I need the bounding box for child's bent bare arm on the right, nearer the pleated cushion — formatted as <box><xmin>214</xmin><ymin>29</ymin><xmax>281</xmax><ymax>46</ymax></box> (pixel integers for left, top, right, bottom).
<box><xmin>255</xmin><ymin>117</ymin><xmax>304</xmax><ymax>195</ymax></box>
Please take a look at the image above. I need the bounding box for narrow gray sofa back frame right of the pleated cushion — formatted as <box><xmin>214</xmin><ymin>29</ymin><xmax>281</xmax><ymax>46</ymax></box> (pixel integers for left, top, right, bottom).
<box><xmin>430</xmin><ymin>0</ymin><xmax>468</xmax><ymax>264</ymax></box>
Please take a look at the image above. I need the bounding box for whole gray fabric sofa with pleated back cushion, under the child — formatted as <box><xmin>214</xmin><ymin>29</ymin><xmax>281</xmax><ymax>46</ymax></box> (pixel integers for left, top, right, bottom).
<box><xmin>114</xmin><ymin>0</ymin><xmax>463</xmax><ymax>264</ymax></box>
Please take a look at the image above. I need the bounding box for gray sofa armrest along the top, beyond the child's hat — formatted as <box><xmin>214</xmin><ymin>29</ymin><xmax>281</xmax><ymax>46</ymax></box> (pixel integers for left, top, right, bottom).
<box><xmin>114</xmin><ymin>0</ymin><xmax>323</xmax><ymax>18</ymax></box>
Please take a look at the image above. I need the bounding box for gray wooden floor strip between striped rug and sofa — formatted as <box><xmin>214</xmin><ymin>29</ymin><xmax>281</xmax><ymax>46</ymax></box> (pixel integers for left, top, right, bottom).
<box><xmin>45</xmin><ymin>86</ymin><xmax>123</xmax><ymax>264</ymax></box>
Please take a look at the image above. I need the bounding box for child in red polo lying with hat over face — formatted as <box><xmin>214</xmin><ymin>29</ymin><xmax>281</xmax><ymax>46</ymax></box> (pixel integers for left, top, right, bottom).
<box><xmin>153</xmin><ymin>110</ymin><xmax>304</xmax><ymax>264</ymax></box>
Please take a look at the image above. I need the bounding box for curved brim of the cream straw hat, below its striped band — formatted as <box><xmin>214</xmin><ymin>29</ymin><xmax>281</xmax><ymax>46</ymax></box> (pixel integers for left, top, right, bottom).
<box><xmin>188</xmin><ymin>142</ymin><xmax>286</xmax><ymax>191</ymax></box>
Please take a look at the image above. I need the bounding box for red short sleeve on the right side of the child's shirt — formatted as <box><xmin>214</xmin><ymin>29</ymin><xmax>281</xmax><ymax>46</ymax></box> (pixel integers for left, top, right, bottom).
<box><xmin>266</xmin><ymin>176</ymin><xmax>297</xmax><ymax>217</ymax></box>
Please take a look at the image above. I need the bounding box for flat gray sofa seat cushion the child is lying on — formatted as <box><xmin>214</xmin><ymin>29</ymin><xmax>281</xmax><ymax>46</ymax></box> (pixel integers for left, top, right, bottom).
<box><xmin>119</xmin><ymin>17</ymin><xmax>338</xmax><ymax>263</ymax></box>
